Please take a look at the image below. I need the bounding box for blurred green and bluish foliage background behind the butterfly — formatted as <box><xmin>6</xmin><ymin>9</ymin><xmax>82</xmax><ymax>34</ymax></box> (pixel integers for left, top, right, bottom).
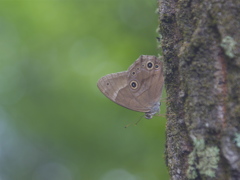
<box><xmin>0</xmin><ymin>0</ymin><xmax>169</xmax><ymax>180</ymax></box>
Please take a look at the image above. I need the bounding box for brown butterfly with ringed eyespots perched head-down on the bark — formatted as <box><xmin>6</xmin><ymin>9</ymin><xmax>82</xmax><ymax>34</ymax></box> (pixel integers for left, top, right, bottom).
<box><xmin>97</xmin><ymin>55</ymin><xmax>164</xmax><ymax>119</ymax></box>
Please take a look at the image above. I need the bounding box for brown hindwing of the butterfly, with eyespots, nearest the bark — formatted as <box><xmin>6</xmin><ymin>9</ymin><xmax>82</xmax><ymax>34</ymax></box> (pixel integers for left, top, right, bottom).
<box><xmin>127</xmin><ymin>55</ymin><xmax>164</xmax><ymax>112</ymax></box>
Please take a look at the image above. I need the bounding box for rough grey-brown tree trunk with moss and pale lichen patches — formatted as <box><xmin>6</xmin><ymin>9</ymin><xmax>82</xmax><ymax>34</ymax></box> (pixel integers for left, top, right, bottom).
<box><xmin>158</xmin><ymin>0</ymin><xmax>240</xmax><ymax>180</ymax></box>
